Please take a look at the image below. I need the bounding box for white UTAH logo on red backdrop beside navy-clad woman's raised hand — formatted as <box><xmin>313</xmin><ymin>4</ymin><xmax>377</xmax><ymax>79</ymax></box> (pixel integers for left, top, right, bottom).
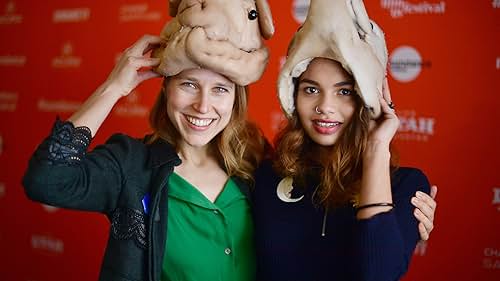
<box><xmin>396</xmin><ymin>110</ymin><xmax>436</xmax><ymax>142</ymax></box>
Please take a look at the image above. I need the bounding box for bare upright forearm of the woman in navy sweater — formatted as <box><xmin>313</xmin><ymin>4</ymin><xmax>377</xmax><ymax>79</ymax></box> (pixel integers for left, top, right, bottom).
<box><xmin>357</xmin><ymin>143</ymin><xmax>392</xmax><ymax>219</ymax></box>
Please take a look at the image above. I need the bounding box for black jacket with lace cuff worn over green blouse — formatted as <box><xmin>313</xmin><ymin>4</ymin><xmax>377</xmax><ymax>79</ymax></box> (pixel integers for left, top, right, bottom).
<box><xmin>23</xmin><ymin>120</ymin><xmax>252</xmax><ymax>281</ymax></box>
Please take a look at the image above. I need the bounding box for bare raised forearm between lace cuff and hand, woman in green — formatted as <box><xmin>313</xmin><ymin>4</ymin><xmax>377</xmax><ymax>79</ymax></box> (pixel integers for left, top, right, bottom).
<box><xmin>68</xmin><ymin>83</ymin><xmax>121</xmax><ymax>137</ymax></box>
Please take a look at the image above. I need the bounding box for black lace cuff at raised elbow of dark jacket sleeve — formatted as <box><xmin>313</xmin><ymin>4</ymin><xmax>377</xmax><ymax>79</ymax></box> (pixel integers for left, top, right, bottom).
<box><xmin>37</xmin><ymin>118</ymin><xmax>92</xmax><ymax>165</ymax></box>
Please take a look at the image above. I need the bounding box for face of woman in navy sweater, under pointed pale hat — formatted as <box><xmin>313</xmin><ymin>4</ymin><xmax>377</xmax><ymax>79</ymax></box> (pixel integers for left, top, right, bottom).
<box><xmin>296</xmin><ymin>58</ymin><xmax>356</xmax><ymax>146</ymax></box>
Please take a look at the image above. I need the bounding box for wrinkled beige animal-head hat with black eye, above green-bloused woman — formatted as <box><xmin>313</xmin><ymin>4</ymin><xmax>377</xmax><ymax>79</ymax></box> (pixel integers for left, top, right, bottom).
<box><xmin>153</xmin><ymin>0</ymin><xmax>274</xmax><ymax>86</ymax></box>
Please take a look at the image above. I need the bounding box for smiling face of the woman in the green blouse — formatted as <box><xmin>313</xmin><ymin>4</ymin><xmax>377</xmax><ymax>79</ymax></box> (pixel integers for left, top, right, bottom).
<box><xmin>165</xmin><ymin>69</ymin><xmax>236</xmax><ymax>147</ymax></box>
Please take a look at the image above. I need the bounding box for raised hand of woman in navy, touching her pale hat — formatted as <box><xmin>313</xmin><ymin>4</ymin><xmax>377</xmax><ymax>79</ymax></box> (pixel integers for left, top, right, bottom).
<box><xmin>368</xmin><ymin>77</ymin><xmax>399</xmax><ymax>145</ymax></box>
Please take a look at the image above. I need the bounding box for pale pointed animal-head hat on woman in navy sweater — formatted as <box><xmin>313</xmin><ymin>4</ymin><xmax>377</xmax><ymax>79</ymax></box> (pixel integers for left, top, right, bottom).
<box><xmin>278</xmin><ymin>0</ymin><xmax>387</xmax><ymax>118</ymax></box>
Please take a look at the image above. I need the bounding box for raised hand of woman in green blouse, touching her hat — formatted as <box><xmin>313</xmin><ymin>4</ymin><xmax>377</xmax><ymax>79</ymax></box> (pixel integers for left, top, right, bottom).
<box><xmin>105</xmin><ymin>35</ymin><xmax>164</xmax><ymax>97</ymax></box>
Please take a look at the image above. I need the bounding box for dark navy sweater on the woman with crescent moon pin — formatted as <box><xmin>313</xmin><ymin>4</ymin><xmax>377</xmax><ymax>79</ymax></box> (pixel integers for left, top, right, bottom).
<box><xmin>253</xmin><ymin>161</ymin><xmax>430</xmax><ymax>281</ymax></box>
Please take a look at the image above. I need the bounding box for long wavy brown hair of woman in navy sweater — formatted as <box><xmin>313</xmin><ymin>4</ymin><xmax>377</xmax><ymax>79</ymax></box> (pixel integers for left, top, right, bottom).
<box><xmin>274</xmin><ymin>80</ymin><xmax>398</xmax><ymax>208</ymax></box>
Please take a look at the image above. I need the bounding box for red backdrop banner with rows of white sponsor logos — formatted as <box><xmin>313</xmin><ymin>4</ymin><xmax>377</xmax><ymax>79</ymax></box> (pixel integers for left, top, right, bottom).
<box><xmin>0</xmin><ymin>0</ymin><xmax>500</xmax><ymax>281</ymax></box>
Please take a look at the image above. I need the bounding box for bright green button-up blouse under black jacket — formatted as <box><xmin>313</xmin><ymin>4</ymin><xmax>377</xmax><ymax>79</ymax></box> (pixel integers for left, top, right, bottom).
<box><xmin>161</xmin><ymin>173</ymin><xmax>255</xmax><ymax>281</ymax></box>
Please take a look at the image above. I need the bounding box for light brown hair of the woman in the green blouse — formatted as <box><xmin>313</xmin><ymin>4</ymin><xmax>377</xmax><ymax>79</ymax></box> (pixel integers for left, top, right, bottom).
<box><xmin>148</xmin><ymin>77</ymin><xmax>265</xmax><ymax>183</ymax></box>
